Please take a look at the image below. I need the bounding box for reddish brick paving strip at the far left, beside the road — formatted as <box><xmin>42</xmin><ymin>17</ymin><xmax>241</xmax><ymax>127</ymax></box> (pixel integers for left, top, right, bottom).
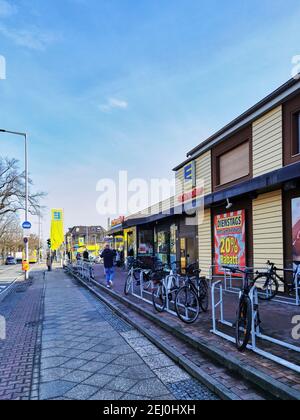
<box><xmin>0</xmin><ymin>273</ymin><xmax>43</xmax><ymax>400</ymax></box>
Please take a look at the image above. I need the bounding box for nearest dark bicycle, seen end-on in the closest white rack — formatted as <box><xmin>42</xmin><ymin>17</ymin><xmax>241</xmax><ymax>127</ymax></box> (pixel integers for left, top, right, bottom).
<box><xmin>223</xmin><ymin>266</ymin><xmax>261</xmax><ymax>352</ymax></box>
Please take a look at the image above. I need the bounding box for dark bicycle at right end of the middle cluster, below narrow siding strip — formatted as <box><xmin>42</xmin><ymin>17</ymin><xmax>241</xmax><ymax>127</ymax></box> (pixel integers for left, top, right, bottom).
<box><xmin>175</xmin><ymin>265</ymin><xmax>209</xmax><ymax>324</ymax></box>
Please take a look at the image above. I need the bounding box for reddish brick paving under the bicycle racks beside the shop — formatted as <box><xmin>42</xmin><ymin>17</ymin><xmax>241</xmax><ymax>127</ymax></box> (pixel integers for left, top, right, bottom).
<box><xmin>95</xmin><ymin>265</ymin><xmax>300</xmax><ymax>398</ymax></box>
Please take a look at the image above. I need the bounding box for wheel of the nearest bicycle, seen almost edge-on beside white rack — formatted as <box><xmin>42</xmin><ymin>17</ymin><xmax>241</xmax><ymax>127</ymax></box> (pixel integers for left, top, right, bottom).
<box><xmin>236</xmin><ymin>296</ymin><xmax>252</xmax><ymax>351</ymax></box>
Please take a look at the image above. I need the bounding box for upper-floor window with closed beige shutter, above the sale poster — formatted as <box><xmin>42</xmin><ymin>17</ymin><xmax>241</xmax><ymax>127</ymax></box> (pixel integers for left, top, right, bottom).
<box><xmin>218</xmin><ymin>142</ymin><xmax>250</xmax><ymax>185</ymax></box>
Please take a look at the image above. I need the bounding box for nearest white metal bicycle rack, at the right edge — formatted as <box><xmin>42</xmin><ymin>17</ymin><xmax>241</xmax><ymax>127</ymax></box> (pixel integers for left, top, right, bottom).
<box><xmin>211</xmin><ymin>280</ymin><xmax>300</xmax><ymax>373</ymax></box>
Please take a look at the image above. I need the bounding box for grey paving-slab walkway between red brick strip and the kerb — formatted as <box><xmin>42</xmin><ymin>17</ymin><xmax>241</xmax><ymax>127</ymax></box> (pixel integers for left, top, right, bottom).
<box><xmin>38</xmin><ymin>270</ymin><xmax>217</xmax><ymax>400</ymax></box>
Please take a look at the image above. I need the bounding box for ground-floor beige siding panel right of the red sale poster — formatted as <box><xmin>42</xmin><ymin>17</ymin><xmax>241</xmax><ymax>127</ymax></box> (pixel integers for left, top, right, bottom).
<box><xmin>253</xmin><ymin>190</ymin><xmax>283</xmax><ymax>268</ymax></box>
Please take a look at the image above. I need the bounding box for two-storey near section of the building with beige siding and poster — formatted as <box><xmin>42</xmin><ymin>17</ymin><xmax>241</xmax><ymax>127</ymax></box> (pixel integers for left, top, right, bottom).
<box><xmin>174</xmin><ymin>79</ymin><xmax>300</xmax><ymax>276</ymax></box>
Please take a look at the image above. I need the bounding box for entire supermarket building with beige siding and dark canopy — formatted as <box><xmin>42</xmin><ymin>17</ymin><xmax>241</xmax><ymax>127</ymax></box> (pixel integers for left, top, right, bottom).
<box><xmin>123</xmin><ymin>79</ymin><xmax>300</xmax><ymax>274</ymax></box>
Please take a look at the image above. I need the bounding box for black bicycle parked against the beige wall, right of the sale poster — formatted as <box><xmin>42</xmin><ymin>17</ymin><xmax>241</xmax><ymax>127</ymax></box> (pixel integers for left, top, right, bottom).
<box><xmin>255</xmin><ymin>261</ymin><xmax>300</xmax><ymax>301</ymax></box>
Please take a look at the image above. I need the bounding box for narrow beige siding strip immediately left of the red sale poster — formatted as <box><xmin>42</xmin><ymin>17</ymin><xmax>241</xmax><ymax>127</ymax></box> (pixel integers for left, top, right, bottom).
<box><xmin>198</xmin><ymin>209</ymin><xmax>212</xmax><ymax>276</ymax></box>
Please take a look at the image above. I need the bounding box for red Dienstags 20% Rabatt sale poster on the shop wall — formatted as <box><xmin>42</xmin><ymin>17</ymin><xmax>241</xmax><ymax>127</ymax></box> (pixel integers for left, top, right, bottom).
<box><xmin>214</xmin><ymin>210</ymin><xmax>247</xmax><ymax>274</ymax></box>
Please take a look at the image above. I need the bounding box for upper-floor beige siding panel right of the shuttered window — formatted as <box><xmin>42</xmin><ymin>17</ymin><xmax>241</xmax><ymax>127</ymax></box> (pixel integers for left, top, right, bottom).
<box><xmin>253</xmin><ymin>106</ymin><xmax>283</xmax><ymax>177</ymax></box>
